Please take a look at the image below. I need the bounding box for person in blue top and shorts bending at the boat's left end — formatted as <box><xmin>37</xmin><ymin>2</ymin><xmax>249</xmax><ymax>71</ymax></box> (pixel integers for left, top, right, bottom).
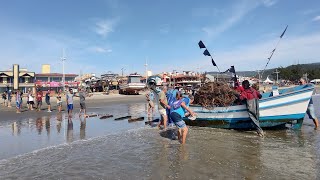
<box><xmin>170</xmin><ymin>91</ymin><xmax>196</xmax><ymax>144</ymax></box>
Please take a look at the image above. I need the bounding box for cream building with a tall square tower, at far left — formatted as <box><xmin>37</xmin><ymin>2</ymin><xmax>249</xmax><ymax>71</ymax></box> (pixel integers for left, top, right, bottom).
<box><xmin>0</xmin><ymin>64</ymin><xmax>35</xmax><ymax>92</ymax></box>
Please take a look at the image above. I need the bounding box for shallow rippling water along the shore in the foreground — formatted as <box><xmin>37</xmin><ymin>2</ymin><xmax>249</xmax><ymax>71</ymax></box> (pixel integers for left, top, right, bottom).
<box><xmin>0</xmin><ymin>100</ymin><xmax>320</xmax><ymax>179</ymax></box>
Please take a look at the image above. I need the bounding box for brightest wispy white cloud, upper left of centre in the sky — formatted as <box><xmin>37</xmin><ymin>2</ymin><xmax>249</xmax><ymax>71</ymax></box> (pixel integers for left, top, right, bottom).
<box><xmin>94</xmin><ymin>18</ymin><xmax>118</xmax><ymax>37</ymax></box>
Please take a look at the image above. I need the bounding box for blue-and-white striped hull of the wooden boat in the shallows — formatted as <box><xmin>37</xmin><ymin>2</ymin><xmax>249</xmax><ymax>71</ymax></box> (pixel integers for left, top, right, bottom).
<box><xmin>185</xmin><ymin>84</ymin><xmax>314</xmax><ymax>129</ymax></box>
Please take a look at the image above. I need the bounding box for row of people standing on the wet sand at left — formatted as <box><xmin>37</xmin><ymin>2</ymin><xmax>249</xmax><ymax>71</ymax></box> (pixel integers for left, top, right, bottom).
<box><xmin>2</xmin><ymin>88</ymin><xmax>91</xmax><ymax>117</ymax></box>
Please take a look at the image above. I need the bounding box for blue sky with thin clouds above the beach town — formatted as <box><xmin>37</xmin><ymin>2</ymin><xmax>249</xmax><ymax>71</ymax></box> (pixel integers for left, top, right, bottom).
<box><xmin>0</xmin><ymin>0</ymin><xmax>320</xmax><ymax>74</ymax></box>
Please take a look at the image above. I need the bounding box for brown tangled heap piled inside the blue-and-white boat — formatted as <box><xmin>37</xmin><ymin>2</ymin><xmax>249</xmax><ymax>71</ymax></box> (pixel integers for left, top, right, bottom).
<box><xmin>194</xmin><ymin>82</ymin><xmax>238</xmax><ymax>109</ymax></box>
